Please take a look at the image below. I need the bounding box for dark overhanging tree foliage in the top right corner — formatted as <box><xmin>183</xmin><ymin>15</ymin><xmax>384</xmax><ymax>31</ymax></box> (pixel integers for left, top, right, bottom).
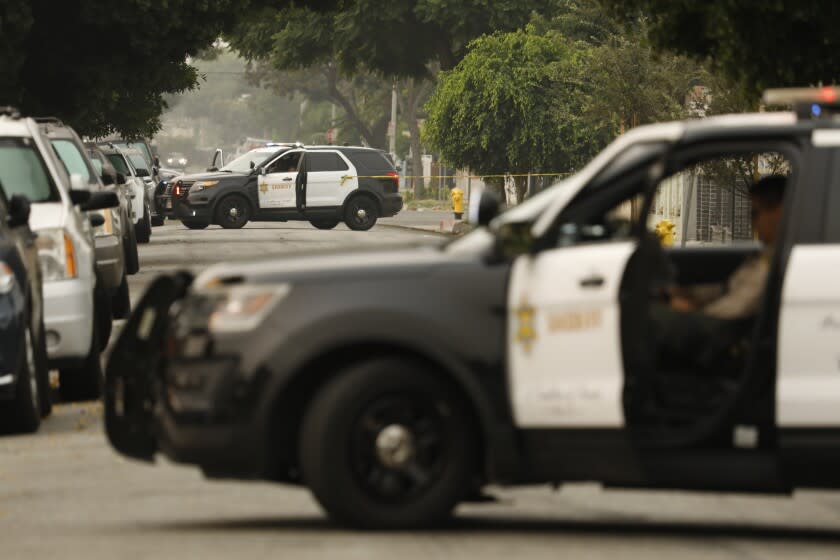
<box><xmin>601</xmin><ymin>0</ymin><xmax>840</xmax><ymax>95</ymax></box>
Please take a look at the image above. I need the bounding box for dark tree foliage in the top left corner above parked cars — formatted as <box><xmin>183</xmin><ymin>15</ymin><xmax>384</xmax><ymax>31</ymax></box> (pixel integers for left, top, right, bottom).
<box><xmin>0</xmin><ymin>0</ymin><xmax>254</xmax><ymax>135</ymax></box>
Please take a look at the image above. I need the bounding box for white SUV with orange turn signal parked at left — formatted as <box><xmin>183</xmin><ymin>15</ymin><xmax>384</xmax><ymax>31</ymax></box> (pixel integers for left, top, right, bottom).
<box><xmin>0</xmin><ymin>109</ymin><xmax>119</xmax><ymax>400</ymax></box>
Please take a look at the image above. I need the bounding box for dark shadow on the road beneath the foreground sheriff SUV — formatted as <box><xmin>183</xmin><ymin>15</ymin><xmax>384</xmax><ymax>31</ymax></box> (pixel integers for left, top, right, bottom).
<box><xmin>136</xmin><ymin>515</ymin><xmax>840</xmax><ymax>543</ymax></box>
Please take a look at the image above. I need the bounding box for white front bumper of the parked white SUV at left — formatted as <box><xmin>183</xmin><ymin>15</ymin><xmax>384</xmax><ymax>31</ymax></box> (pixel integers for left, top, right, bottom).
<box><xmin>44</xmin><ymin>278</ymin><xmax>94</xmax><ymax>361</ymax></box>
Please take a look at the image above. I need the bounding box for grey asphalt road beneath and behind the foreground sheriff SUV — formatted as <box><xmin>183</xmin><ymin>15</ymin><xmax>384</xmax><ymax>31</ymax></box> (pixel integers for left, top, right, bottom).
<box><xmin>0</xmin><ymin>224</ymin><xmax>840</xmax><ymax>560</ymax></box>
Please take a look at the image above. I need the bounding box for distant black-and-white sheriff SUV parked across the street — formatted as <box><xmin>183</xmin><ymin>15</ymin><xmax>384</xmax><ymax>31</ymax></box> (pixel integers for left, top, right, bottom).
<box><xmin>162</xmin><ymin>144</ymin><xmax>403</xmax><ymax>231</ymax></box>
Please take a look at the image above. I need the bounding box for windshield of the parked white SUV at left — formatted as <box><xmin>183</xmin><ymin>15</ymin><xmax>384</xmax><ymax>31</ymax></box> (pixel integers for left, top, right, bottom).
<box><xmin>0</xmin><ymin>138</ymin><xmax>60</xmax><ymax>202</ymax></box>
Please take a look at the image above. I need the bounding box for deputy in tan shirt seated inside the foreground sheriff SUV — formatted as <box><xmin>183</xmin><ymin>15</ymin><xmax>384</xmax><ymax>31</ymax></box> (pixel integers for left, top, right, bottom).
<box><xmin>651</xmin><ymin>175</ymin><xmax>787</xmax><ymax>371</ymax></box>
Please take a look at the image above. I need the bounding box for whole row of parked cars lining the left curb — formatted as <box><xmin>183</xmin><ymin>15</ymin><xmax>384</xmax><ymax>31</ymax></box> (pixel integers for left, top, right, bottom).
<box><xmin>0</xmin><ymin>107</ymin><xmax>174</xmax><ymax>432</ymax></box>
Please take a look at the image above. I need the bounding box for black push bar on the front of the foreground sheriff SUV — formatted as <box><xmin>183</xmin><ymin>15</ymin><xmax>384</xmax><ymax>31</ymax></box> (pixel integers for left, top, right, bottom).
<box><xmin>104</xmin><ymin>274</ymin><xmax>192</xmax><ymax>461</ymax></box>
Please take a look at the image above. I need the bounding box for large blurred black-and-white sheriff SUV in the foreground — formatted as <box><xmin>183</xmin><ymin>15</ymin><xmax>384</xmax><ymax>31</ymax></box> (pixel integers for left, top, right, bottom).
<box><xmin>105</xmin><ymin>90</ymin><xmax>840</xmax><ymax>528</ymax></box>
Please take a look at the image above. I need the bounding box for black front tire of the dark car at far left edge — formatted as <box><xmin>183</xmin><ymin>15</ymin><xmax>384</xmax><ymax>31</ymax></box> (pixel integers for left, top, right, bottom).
<box><xmin>3</xmin><ymin>320</ymin><xmax>41</xmax><ymax>433</ymax></box>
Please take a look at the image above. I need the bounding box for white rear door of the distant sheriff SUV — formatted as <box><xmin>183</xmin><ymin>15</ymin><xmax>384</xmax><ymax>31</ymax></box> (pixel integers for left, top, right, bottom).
<box><xmin>306</xmin><ymin>150</ymin><xmax>358</xmax><ymax>208</ymax></box>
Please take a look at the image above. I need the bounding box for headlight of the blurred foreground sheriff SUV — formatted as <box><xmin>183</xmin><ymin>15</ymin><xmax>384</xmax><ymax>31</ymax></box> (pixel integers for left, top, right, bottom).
<box><xmin>208</xmin><ymin>284</ymin><xmax>291</xmax><ymax>332</ymax></box>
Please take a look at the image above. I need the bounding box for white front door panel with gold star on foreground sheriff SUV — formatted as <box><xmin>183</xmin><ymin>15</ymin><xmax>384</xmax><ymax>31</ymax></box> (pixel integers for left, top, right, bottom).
<box><xmin>508</xmin><ymin>240</ymin><xmax>636</xmax><ymax>428</ymax></box>
